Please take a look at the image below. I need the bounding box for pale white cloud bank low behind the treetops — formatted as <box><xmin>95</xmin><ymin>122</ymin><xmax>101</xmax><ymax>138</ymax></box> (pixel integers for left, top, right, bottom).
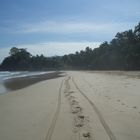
<box><xmin>0</xmin><ymin>42</ymin><xmax>101</xmax><ymax>62</ymax></box>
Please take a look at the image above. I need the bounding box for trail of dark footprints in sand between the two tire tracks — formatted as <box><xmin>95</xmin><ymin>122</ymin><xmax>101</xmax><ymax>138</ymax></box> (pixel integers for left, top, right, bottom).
<box><xmin>64</xmin><ymin>77</ymin><xmax>93</xmax><ymax>140</ymax></box>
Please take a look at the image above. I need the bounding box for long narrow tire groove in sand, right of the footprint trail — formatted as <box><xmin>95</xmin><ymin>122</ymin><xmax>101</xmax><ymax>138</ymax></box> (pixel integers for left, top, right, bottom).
<box><xmin>72</xmin><ymin>77</ymin><xmax>116</xmax><ymax>140</ymax></box>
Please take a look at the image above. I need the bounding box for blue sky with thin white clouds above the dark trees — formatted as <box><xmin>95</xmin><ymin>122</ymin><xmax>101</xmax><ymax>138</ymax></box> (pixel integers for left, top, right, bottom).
<box><xmin>0</xmin><ymin>0</ymin><xmax>140</xmax><ymax>62</ymax></box>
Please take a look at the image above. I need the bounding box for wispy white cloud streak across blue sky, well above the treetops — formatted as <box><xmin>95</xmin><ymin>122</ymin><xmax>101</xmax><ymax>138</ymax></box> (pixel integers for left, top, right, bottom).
<box><xmin>14</xmin><ymin>21</ymin><xmax>135</xmax><ymax>34</ymax></box>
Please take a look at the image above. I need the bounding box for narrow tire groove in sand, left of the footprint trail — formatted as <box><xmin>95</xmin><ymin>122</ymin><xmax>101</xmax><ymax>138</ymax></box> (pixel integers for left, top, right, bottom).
<box><xmin>45</xmin><ymin>80</ymin><xmax>64</xmax><ymax>140</ymax></box>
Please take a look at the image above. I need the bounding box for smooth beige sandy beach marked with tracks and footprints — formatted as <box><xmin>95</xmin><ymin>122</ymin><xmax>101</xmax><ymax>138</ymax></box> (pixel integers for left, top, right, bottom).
<box><xmin>0</xmin><ymin>71</ymin><xmax>140</xmax><ymax>140</ymax></box>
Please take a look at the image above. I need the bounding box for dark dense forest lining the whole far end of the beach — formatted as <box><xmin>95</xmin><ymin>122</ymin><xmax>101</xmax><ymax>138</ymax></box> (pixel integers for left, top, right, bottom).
<box><xmin>0</xmin><ymin>23</ymin><xmax>140</xmax><ymax>70</ymax></box>
